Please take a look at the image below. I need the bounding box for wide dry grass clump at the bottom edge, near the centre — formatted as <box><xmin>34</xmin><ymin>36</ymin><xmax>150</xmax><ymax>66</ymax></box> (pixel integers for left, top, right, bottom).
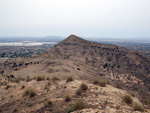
<box><xmin>68</xmin><ymin>100</ymin><xmax>88</xmax><ymax>113</ymax></box>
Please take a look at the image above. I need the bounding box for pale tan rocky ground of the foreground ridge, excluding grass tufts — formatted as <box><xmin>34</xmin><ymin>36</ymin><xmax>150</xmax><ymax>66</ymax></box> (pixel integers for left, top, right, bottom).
<box><xmin>0</xmin><ymin>76</ymin><xmax>150</xmax><ymax>113</ymax></box>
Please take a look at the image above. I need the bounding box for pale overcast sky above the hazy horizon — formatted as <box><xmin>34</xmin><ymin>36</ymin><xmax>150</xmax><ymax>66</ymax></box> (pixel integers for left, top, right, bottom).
<box><xmin>0</xmin><ymin>0</ymin><xmax>150</xmax><ymax>38</ymax></box>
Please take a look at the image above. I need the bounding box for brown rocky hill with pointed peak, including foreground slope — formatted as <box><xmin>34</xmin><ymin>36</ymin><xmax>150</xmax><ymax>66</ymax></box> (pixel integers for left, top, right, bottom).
<box><xmin>0</xmin><ymin>35</ymin><xmax>150</xmax><ymax>113</ymax></box>
